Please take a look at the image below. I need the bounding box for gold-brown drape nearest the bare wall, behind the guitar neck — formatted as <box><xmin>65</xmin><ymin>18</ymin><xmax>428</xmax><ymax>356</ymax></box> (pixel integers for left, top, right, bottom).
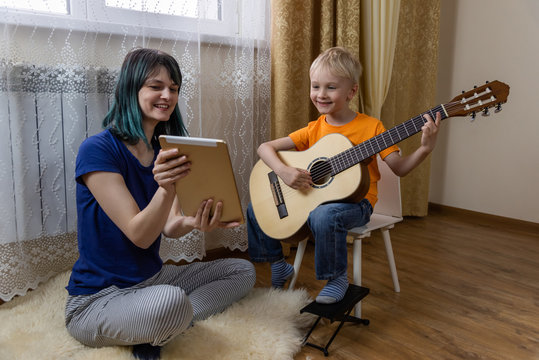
<box><xmin>381</xmin><ymin>0</ymin><xmax>444</xmax><ymax>216</ymax></box>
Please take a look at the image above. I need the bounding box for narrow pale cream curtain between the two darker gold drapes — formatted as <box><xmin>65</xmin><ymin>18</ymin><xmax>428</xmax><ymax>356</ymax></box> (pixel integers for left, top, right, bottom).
<box><xmin>360</xmin><ymin>0</ymin><xmax>400</xmax><ymax>119</ymax></box>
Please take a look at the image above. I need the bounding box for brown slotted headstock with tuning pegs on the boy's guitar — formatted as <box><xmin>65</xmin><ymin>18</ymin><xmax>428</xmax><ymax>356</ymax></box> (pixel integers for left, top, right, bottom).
<box><xmin>444</xmin><ymin>80</ymin><xmax>509</xmax><ymax>119</ymax></box>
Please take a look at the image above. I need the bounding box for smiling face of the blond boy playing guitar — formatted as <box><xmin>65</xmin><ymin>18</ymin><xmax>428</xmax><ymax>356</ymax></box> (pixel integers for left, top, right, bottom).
<box><xmin>311</xmin><ymin>67</ymin><xmax>357</xmax><ymax>118</ymax></box>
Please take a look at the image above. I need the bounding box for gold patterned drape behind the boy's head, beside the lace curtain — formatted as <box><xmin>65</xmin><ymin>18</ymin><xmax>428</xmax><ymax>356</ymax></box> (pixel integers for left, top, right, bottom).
<box><xmin>271</xmin><ymin>0</ymin><xmax>360</xmax><ymax>138</ymax></box>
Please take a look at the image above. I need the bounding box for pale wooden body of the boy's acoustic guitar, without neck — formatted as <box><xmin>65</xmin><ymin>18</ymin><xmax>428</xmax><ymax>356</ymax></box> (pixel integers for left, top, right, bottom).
<box><xmin>249</xmin><ymin>134</ymin><xmax>370</xmax><ymax>239</ymax></box>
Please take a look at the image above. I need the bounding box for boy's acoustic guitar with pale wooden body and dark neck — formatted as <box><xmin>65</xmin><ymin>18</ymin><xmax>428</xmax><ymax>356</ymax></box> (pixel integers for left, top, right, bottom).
<box><xmin>249</xmin><ymin>81</ymin><xmax>509</xmax><ymax>239</ymax></box>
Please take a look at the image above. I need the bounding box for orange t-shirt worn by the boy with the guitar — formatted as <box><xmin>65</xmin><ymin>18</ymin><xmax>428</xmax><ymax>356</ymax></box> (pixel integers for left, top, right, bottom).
<box><xmin>288</xmin><ymin>113</ymin><xmax>399</xmax><ymax>207</ymax></box>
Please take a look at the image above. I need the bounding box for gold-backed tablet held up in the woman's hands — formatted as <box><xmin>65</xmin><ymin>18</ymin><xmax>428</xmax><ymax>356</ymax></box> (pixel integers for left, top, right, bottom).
<box><xmin>159</xmin><ymin>135</ymin><xmax>244</xmax><ymax>223</ymax></box>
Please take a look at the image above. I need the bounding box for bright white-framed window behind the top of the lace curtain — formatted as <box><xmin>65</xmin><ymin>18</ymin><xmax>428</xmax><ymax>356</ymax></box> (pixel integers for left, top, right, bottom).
<box><xmin>0</xmin><ymin>0</ymin><xmax>258</xmax><ymax>38</ymax></box>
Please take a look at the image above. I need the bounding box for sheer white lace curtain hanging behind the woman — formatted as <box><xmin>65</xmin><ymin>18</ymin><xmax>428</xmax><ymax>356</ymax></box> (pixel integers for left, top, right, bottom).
<box><xmin>0</xmin><ymin>0</ymin><xmax>270</xmax><ymax>301</ymax></box>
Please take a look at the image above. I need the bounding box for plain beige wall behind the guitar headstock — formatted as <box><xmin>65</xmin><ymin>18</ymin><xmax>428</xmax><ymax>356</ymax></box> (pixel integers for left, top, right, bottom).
<box><xmin>429</xmin><ymin>0</ymin><xmax>539</xmax><ymax>223</ymax></box>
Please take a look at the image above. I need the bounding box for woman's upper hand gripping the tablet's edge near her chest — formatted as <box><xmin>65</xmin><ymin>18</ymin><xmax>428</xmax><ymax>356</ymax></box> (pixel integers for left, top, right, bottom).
<box><xmin>153</xmin><ymin>149</ymin><xmax>191</xmax><ymax>191</ymax></box>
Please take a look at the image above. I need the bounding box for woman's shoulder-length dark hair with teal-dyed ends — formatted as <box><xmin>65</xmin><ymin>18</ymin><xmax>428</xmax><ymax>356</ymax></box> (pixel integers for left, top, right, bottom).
<box><xmin>103</xmin><ymin>48</ymin><xmax>187</xmax><ymax>145</ymax></box>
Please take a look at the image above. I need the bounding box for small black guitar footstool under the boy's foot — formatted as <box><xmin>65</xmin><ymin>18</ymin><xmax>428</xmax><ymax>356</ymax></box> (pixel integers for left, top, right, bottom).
<box><xmin>300</xmin><ymin>284</ymin><xmax>369</xmax><ymax>356</ymax></box>
